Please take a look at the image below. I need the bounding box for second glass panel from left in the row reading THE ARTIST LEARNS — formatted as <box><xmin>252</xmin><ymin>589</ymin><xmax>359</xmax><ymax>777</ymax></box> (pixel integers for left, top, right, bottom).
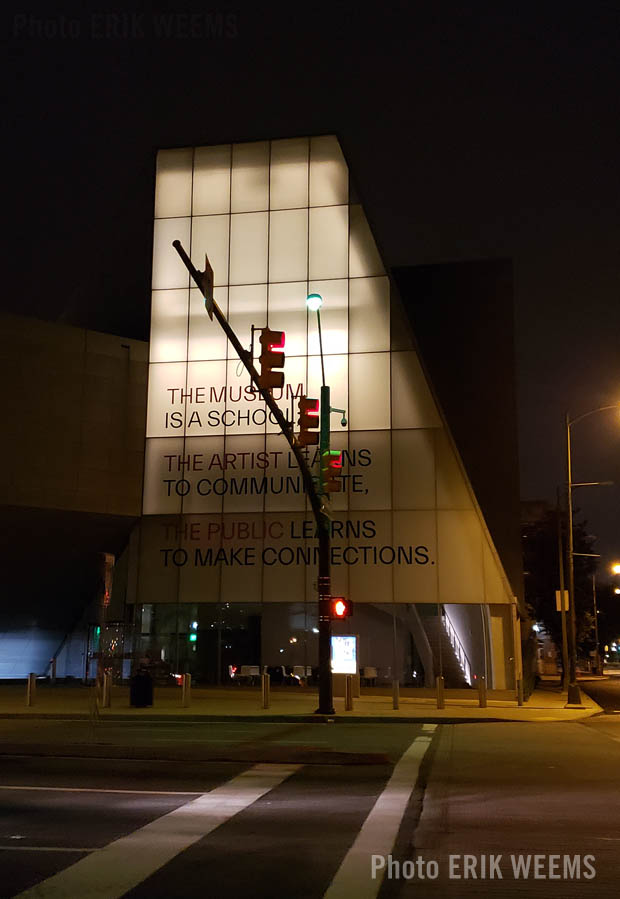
<box><xmin>178</xmin><ymin>437</ymin><xmax>226</xmax><ymax>513</ymax></box>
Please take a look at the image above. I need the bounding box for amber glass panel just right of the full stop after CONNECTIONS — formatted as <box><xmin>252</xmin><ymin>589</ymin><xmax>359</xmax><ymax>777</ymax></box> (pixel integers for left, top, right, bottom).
<box><xmin>437</xmin><ymin>512</ymin><xmax>485</xmax><ymax>603</ymax></box>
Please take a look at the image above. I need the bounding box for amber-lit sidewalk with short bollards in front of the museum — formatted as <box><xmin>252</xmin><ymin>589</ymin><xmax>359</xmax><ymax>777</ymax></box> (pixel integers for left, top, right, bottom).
<box><xmin>0</xmin><ymin>683</ymin><xmax>602</xmax><ymax>723</ymax></box>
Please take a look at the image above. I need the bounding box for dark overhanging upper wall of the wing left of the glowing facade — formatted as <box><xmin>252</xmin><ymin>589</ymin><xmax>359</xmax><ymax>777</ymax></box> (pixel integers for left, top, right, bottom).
<box><xmin>0</xmin><ymin>315</ymin><xmax>148</xmax><ymax>516</ymax></box>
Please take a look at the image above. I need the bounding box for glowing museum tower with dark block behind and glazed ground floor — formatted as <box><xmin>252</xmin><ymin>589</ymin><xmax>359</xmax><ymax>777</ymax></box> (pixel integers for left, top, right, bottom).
<box><xmin>0</xmin><ymin>136</ymin><xmax>521</xmax><ymax>689</ymax></box>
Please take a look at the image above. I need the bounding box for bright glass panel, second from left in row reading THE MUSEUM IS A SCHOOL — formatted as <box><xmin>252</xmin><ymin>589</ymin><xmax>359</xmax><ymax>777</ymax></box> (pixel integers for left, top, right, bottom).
<box><xmin>185</xmin><ymin>361</ymin><xmax>226</xmax><ymax>437</ymax></box>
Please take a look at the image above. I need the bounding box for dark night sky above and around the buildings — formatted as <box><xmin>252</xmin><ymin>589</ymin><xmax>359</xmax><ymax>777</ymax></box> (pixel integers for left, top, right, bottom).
<box><xmin>3</xmin><ymin>2</ymin><xmax>620</xmax><ymax>572</ymax></box>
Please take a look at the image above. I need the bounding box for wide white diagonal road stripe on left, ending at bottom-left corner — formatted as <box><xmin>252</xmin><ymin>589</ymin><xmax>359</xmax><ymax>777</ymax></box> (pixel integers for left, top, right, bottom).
<box><xmin>18</xmin><ymin>765</ymin><xmax>301</xmax><ymax>899</ymax></box>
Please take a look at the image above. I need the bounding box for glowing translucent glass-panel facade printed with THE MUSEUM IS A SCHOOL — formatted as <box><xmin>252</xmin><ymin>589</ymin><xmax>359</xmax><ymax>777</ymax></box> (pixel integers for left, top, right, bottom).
<box><xmin>142</xmin><ymin>136</ymin><xmax>512</xmax><ymax>632</ymax></box>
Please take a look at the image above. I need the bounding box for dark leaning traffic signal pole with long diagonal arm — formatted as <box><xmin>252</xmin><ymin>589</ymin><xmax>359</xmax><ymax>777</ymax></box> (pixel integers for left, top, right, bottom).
<box><xmin>172</xmin><ymin>240</ymin><xmax>334</xmax><ymax>715</ymax></box>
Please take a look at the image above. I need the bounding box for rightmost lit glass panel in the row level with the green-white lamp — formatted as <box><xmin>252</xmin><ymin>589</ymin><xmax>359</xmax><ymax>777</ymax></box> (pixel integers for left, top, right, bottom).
<box><xmin>349</xmin><ymin>277</ymin><xmax>390</xmax><ymax>353</ymax></box>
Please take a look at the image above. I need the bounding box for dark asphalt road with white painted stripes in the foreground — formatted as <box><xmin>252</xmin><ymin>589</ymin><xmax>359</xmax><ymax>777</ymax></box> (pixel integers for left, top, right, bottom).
<box><xmin>0</xmin><ymin>715</ymin><xmax>620</xmax><ymax>899</ymax></box>
